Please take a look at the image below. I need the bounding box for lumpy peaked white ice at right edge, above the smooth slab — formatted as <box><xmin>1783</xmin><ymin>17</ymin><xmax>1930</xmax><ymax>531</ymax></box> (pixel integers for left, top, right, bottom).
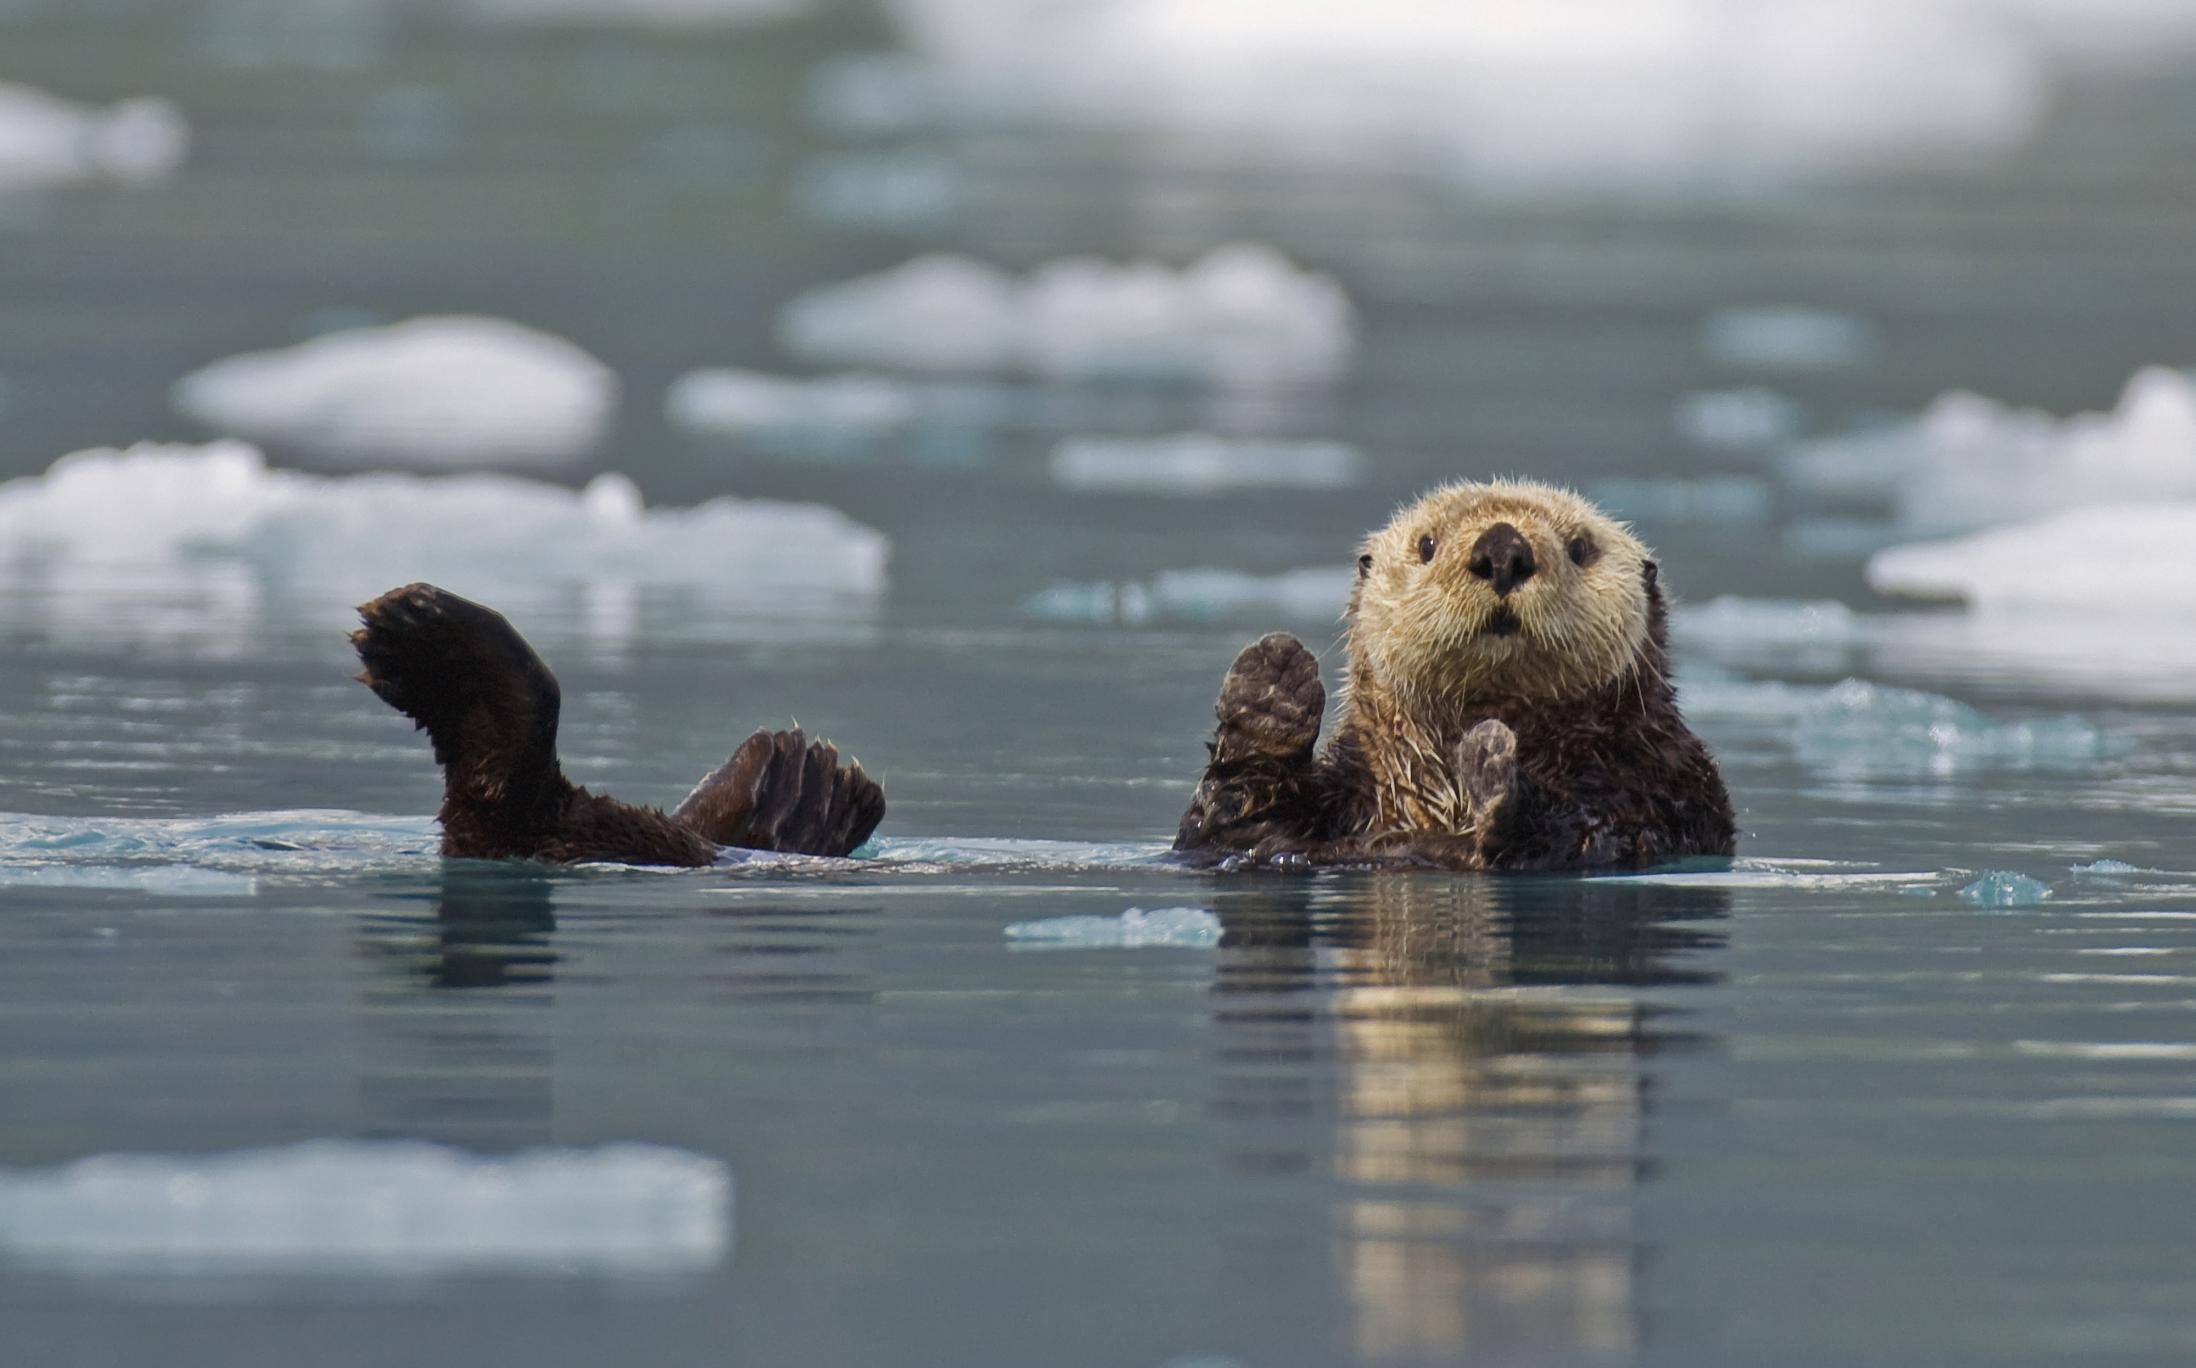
<box><xmin>1785</xmin><ymin>367</ymin><xmax>2196</xmax><ymax>540</ymax></box>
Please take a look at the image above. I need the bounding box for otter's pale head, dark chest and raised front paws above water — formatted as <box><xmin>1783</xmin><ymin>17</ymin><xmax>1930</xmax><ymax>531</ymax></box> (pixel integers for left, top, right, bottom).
<box><xmin>1175</xmin><ymin>481</ymin><xmax>1737</xmax><ymax>870</ymax></box>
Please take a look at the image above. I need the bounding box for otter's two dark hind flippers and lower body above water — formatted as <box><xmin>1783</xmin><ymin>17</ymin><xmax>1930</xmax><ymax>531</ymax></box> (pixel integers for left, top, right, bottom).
<box><xmin>351</xmin><ymin>584</ymin><xmax>885</xmax><ymax>865</ymax></box>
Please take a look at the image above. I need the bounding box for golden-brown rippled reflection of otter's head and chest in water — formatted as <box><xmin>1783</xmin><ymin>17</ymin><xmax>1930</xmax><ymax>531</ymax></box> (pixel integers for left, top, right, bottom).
<box><xmin>1217</xmin><ymin>874</ymin><xmax>1728</xmax><ymax>1361</ymax></box>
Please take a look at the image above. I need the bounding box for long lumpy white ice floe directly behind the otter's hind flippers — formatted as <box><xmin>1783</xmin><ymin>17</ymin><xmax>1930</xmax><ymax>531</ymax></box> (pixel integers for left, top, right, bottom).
<box><xmin>0</xmin><ymin>441</ymin><xmax>887</xmax><ymax>604</ymax></box>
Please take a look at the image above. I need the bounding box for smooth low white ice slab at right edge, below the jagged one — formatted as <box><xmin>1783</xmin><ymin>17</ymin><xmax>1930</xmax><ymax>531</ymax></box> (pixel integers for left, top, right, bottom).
<box><xmin>1869</xmin><ymin>502</ymin><xmax>2196</xmax><ymax>610</ymax></box>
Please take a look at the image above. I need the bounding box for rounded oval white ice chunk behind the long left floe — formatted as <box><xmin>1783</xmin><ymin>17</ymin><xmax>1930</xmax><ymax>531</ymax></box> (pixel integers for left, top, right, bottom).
<box><xmin>173</xmin><ymin>316</ymin><xmax>617</xmax><ymax>468</ymax></box>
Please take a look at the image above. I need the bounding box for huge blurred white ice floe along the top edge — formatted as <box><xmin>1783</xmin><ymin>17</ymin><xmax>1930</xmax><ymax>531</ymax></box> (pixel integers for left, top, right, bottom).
<box><xmin>872</xmin><ymin>0</ymin><xmax>2073</xmax><ymax>193</ymax></box>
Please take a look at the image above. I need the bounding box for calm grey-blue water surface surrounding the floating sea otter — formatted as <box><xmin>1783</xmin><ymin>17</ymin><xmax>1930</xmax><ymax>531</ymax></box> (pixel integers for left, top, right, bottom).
<box><xmin>0</xmin><ymin>0</ymin><xmax>2196</xmax><ymax>1368</ymax></box>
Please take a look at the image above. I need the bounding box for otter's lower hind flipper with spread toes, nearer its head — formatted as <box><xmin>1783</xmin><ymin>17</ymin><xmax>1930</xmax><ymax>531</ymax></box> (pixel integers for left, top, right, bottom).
<box><xmin>672</xmin><ymin>731</ymin><xmax>885</xmax><ymax>854</ymax></box>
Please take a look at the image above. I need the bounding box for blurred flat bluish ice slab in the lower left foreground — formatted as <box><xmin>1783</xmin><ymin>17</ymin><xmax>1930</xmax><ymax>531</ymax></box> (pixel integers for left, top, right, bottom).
<box><xmin>0</xmin><ymin>1140</ymin><xmax>731</xmax><ymax>1278</ymax></box>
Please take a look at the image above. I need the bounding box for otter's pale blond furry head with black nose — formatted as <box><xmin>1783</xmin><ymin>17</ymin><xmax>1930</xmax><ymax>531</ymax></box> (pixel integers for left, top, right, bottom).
<box><xmin>1351</xmin><ymin>481</ymin><xmax>1654</xmax><ymax>703</ymax></box>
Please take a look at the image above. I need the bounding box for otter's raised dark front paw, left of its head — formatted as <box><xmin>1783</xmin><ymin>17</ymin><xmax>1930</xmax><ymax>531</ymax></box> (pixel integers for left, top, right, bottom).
<box><xmin>1175</xmin><ymin>632</ymin><xmax>1326</xmax><ymax>852</ymax></box>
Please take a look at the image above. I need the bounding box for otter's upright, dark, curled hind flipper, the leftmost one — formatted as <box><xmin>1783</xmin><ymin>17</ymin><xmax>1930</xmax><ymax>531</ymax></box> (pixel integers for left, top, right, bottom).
<box><xmin>351</xmin><ymin>584</ymin><xmax>564</xmax><ymax>830</ymax></box>
